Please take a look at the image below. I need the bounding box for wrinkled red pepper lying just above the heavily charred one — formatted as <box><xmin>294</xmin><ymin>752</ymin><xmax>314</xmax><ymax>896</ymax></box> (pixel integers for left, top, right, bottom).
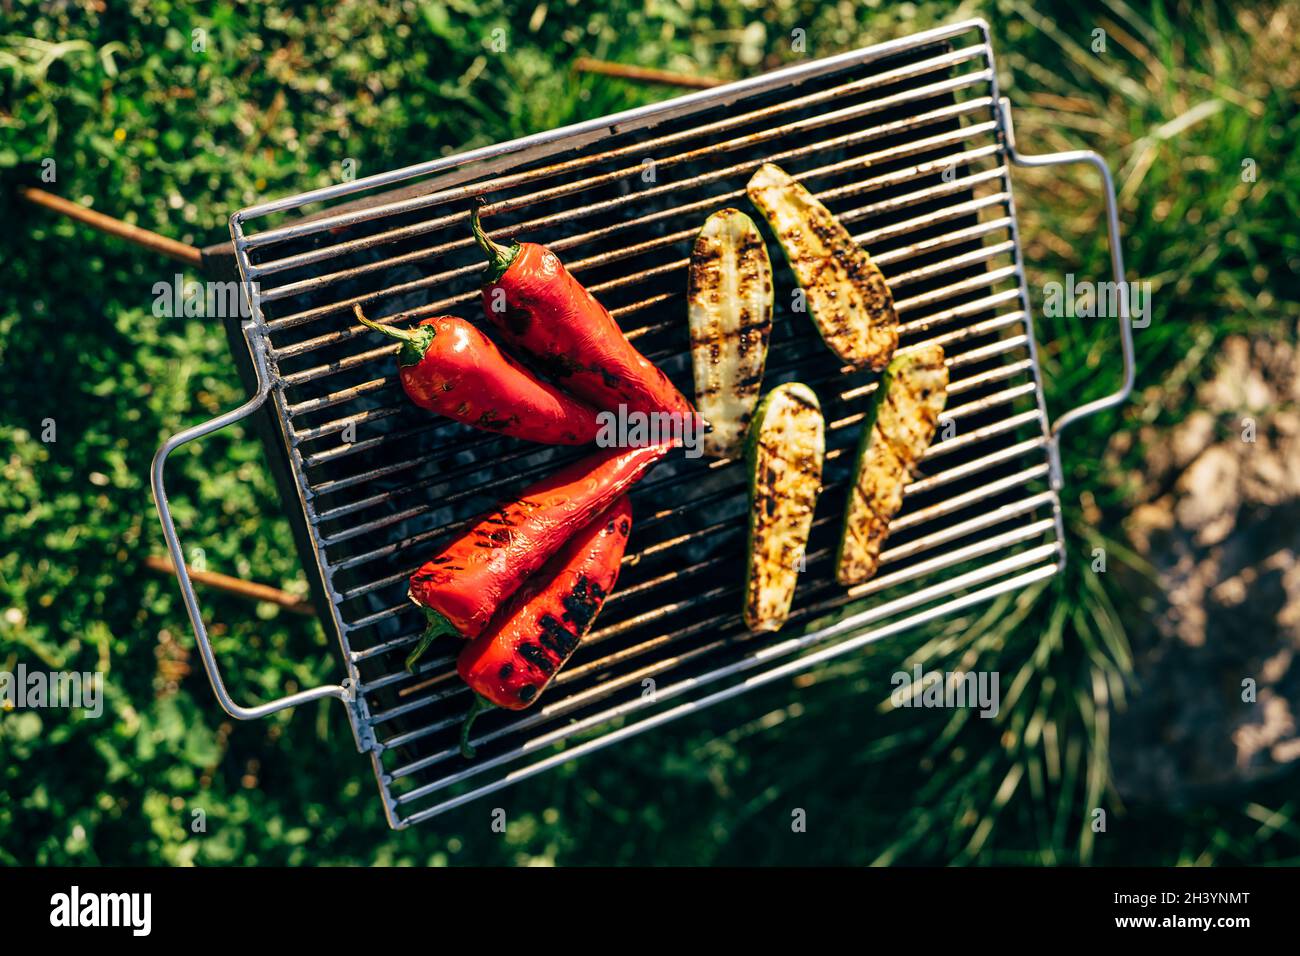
<box><xmin>407</xmin><ymin>444</ymin><xmax>671</xmax><ymax>669</ymax></box>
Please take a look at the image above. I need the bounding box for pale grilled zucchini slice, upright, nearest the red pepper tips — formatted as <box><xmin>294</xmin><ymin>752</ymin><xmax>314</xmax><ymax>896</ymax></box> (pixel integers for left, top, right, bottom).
<box><xmin>686</xmin><ymin>209</ymin><xmax>772</xmax><ymax>458</ymax></box>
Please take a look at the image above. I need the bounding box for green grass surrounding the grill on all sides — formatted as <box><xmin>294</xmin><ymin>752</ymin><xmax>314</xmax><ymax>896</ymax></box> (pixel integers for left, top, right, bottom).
<box><xmin>0</xmin><ymin>0</ymin><xmax>1300</xmax><ymax>864</ymax></box>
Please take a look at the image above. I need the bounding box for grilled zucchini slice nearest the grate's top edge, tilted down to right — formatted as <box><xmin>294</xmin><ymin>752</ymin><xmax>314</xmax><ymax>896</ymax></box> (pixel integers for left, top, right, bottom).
<box><xmin>748</xmin><ymin>163</ymin><xmax>898</xmax><ymax>372</ymax></box>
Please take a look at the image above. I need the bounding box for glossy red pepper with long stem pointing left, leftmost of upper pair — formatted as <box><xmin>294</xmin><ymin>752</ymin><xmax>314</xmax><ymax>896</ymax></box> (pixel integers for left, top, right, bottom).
<box><xmin>352</xmin><ymin>306</ymin><xmax>599</xmax><ymax>445</ymax></box>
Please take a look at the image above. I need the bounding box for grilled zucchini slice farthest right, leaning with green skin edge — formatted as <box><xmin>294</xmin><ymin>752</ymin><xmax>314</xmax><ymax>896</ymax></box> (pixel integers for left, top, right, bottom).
<box><xmin>835</xmin><ymin>345</ymin><xmax>948</xmax><ymax>585</ymax></box>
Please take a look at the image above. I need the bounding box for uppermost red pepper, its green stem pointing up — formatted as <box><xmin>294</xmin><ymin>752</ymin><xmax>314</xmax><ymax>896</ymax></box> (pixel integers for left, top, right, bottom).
<box><xmin>471</xmin><ymin>208</ymin><xmax>694</xmax><ymax>416</ymax></box>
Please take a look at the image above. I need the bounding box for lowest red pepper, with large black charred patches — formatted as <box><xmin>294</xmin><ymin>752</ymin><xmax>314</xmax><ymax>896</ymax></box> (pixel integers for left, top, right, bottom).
<box><xmin>456</xmin><ymin>494</ymin><xmax>632</xmax><ymax>757</ymax></box>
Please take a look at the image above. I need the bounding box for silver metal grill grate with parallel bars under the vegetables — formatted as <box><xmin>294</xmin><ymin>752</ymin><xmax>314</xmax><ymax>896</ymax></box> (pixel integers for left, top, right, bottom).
<box><xmin>155</xmin><ymin>21</ymin><xmax>1128</xmax><ymax>827</ymax></box>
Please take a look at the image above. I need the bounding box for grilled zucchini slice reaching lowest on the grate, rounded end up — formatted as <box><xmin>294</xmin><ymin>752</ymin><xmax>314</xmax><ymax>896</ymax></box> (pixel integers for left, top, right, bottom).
<box><xmin>744</xmin><ymin>382</ymin><xmax>826</xmax><ymax>631</ymax></box>
